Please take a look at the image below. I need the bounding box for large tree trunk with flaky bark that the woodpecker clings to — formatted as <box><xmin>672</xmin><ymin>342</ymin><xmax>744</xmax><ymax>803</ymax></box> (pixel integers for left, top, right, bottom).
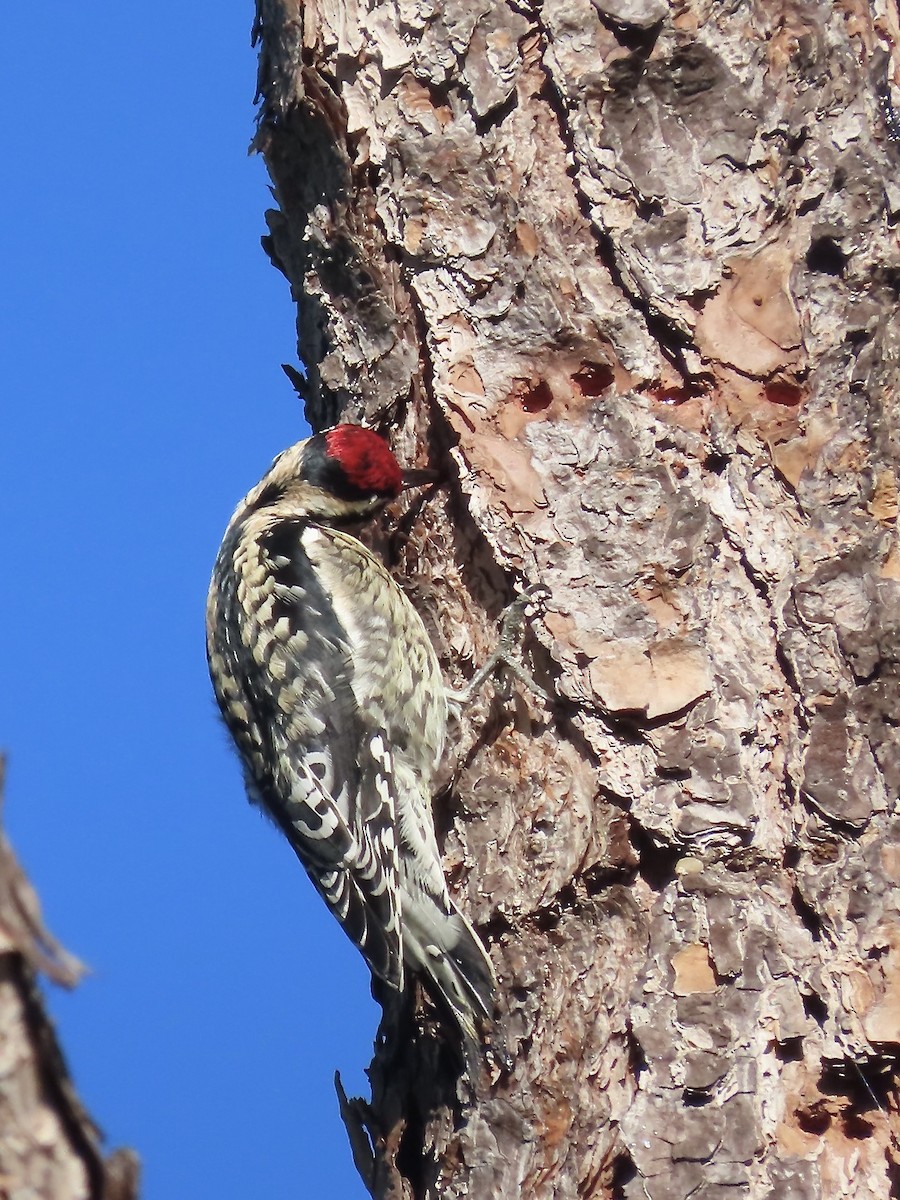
<box><xmin>250</xmin><ymin>0</ymin><xmax>900</xmax><ymax>1200</ymax></box>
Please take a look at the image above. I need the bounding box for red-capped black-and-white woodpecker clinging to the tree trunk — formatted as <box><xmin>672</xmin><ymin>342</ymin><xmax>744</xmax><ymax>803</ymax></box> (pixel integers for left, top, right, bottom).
<box><xmin>206</xmin><ymin>425</ymin><xmax>494</xmax><ymax>1057</ymax></box>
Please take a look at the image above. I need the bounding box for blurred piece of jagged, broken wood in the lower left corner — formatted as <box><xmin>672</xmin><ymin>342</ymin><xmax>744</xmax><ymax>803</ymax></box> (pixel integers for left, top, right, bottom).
<box><xmin>0</xmin><ymin>762</ymin><xmax>138</xmax><ymax>1200</ymax></box>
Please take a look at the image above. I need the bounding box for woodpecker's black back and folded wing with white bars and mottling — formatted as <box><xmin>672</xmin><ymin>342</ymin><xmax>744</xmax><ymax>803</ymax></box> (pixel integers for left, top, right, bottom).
<box><xmin>209</xmin><ymin>521</ymin><xmax>403</xmax><ymax>988</ymax></box>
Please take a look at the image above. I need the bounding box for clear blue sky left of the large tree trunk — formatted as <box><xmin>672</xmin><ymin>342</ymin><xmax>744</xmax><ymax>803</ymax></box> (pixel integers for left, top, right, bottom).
<box><xmin>0</xmin><ymin>9</ymin><xmax>377</xmax><ymax>1200</ymax></box>
